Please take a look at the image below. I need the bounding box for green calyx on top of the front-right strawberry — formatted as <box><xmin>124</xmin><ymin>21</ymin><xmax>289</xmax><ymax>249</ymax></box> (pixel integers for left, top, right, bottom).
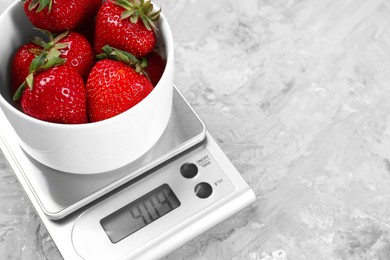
<box><xmin>96</xmin><ymin>45</ymin><xmax>148</xmax><ymax>76</ymax></box>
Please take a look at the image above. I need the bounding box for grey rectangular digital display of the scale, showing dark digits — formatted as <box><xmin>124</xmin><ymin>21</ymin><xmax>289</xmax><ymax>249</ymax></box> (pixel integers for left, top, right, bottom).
<box><xmin>100</xmin><ymin>184</ymin><xmax>180</xmax><ymax>243</ymax></box>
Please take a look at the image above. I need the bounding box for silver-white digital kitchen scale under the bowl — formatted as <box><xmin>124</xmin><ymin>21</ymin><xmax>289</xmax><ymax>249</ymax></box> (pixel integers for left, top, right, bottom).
<box><xmin>0</xmin><ymin>87</ymin><xmax>255</xmax><ymax>260</ymax></box>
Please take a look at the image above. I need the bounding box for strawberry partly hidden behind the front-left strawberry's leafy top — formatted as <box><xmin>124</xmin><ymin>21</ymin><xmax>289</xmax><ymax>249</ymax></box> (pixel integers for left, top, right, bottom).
<box><xmin>11</xmin><ymin>30</ymin><xmax>95</xmax><ymax>90</ymax></box>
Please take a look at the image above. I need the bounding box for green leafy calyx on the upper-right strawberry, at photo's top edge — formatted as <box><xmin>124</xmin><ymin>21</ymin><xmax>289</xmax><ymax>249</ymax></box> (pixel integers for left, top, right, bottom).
<box><xmin>114</xmin><ymin>0</ymin><xmax>161</xmax><ymax>33</ymax></box>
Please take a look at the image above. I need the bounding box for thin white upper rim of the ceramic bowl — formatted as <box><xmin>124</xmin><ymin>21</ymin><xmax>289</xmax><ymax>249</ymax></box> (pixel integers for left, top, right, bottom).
<box><xmin>0</xmin><ymin>1</ymin><xmax>174</xmax><ymax>130</ymax></box>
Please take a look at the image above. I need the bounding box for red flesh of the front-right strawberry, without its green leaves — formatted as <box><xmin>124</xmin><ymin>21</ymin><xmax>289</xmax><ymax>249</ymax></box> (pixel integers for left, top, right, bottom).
<box><xmin>86</xmin><ymin>59</ymin><xmax>153</xmax><ymax>122</ymax></box>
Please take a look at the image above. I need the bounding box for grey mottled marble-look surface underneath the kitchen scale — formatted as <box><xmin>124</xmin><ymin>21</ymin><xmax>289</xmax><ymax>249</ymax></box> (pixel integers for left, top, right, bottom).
<box><xmin>0</xmin><ymin>0</ymin><xmax>390</xmax><ymax>260</ymax></box>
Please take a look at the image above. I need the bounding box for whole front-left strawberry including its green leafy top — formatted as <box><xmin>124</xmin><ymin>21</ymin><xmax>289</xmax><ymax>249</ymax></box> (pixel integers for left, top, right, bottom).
<box><xmin>13</xmin><ymin>34</ymin><xmax>88</xmax><ymax>124</ymax></box>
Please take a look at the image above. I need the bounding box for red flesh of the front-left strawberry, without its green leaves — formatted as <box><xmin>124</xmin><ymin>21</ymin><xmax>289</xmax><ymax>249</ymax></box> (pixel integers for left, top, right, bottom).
<box><xmin>21</xmin><ymin>66</ymin><xmax>88</xmax><ymax>124</ymax></box>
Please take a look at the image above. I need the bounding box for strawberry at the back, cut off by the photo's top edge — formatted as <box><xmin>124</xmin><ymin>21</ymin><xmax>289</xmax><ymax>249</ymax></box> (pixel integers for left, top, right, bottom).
<box><xmin>24</xmin><ymin>0</ymin><xmax>101</xmax><ymax>32</ymax></box>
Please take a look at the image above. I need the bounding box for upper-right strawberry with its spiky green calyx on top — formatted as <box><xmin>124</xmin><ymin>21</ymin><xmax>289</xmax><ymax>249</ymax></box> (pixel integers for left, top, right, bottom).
<box><xmin>94</xmin><ymin>0</ymin><xmax>161</xmax><ymax>57</ymax></box>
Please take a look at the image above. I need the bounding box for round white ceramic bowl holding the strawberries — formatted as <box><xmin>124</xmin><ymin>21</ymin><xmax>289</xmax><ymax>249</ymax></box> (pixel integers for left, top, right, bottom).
<box><xmin>0</xmin><ymin>1</ymin><xmax>174</xmax><ymax>174</ymax></box>
